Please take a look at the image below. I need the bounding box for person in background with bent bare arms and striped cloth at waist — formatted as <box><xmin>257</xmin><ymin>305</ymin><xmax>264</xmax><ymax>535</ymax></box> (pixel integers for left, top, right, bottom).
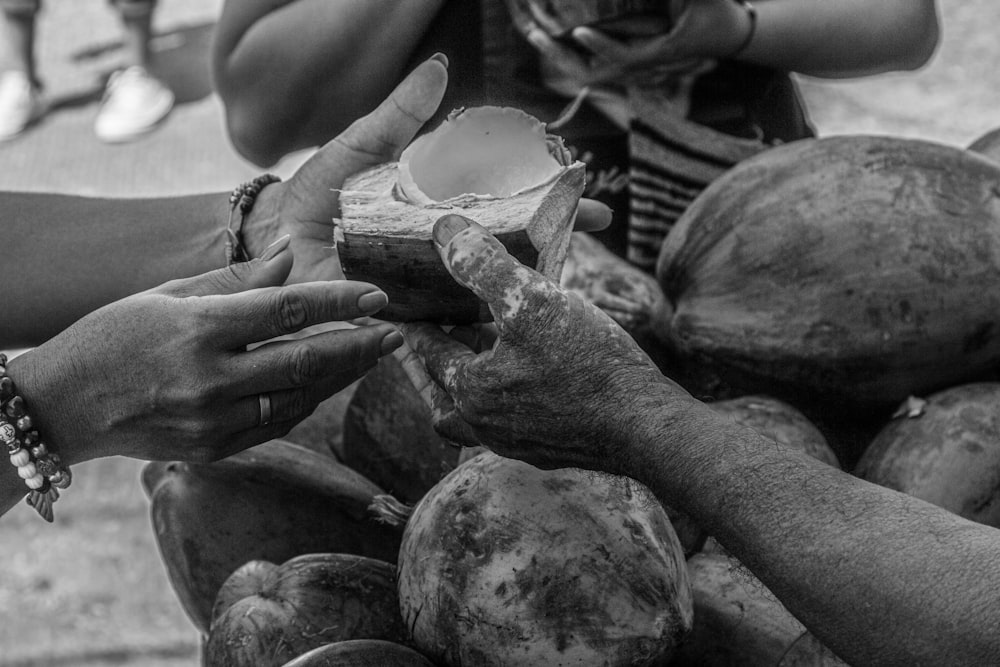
<box><xmin>212</xmin><ymin>0</ymin><xmax>938</xmax><ymax>271</ymax></box>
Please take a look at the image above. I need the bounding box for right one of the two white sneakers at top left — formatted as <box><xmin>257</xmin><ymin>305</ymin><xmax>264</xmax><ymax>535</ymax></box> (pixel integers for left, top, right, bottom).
<box><xmin>94</xmin><ymin>67</ymin><xmax>174</xmax><ymax>143</ymax></box>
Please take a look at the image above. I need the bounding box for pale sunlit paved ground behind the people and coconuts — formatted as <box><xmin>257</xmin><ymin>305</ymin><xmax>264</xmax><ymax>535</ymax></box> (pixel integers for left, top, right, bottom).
<box><xmin>0</xmin><ymin>0</ymin><xmax>1000</xmax><ymax>667</ymax></box>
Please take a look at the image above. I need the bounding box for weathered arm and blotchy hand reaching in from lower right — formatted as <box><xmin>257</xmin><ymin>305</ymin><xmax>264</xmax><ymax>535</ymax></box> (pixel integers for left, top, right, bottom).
<box><xmin>404</xmin><ymin>216</ymin><xmax>1000</xmax><ymax>665</ymax></box>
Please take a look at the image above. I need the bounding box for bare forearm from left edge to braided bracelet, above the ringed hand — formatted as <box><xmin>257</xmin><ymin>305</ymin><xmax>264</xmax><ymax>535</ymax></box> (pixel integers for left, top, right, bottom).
<box><xmin>0</xmin><ymin>193</ymin><xmax>228</xmax><ymax>348</ymax></box>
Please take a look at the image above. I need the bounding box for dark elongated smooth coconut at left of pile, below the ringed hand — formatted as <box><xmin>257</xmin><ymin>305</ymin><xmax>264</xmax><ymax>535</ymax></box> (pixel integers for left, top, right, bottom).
<box><xmin>143</xmin><ymin>440</ymin><xmax>400</xmax><ymax>633</ymax></box>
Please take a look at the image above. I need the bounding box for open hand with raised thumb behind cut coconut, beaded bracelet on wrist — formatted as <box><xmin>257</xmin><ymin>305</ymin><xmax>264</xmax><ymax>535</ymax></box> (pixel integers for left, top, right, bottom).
<box><xmin>248</xmin><ymin>56</ymin><xmax>448</xmax><ymax>283</ymax></box>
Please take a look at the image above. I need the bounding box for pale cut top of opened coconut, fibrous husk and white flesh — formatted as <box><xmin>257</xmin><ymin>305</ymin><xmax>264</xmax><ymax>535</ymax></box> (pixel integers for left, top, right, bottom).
<box><xmin>335</xmin><ymin>107</ymin><xmax>584</xmax><ymax>244</ymax></box>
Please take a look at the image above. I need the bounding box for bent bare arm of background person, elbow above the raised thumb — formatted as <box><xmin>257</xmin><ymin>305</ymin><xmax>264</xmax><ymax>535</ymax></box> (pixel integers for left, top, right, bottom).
<box><xmin>213</xmin><ymin>0</ymin><xmax>444</xmax><ymax>164</ymax></box>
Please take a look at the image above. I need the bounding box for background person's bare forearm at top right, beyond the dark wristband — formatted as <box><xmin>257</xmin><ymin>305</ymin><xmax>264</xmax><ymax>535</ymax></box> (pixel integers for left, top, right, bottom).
<box><xmin>740</xmin><ymin>0</ymin><xmax>938</xmax><ymax>78</ymax></box>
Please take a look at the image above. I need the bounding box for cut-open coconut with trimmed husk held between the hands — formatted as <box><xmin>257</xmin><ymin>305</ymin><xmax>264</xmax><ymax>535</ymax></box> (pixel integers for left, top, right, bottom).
<box><xmin>334</xmin><ymin>107</ymin><xmax>584</xmax><ymax>324</ymax></box>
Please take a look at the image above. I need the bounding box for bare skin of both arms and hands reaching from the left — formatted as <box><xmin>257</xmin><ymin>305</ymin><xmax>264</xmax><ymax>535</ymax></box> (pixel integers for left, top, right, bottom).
<box><xmin>0</xmin><ymin>59</ymin><xmax>447</xmax><ymax>512</ymax></box>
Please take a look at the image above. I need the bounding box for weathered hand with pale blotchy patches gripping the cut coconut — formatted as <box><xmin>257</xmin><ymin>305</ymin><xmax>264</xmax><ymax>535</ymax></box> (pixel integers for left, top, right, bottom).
<box><xmin>400</xmin><ymin>215</ymin><xmax>693</xmax><ymax>472</ymax></box>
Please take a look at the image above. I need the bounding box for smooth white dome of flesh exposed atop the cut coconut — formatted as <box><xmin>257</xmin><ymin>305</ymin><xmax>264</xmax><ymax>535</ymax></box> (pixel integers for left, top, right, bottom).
<box><xmin>399</xmin><ymin>107</ymin><xmax>563</xmax><ymax>204</ymax></box>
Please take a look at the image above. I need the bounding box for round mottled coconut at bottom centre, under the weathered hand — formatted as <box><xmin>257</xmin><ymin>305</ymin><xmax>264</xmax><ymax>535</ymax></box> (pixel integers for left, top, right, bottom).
<box><xmin>399</xmin><ymin>452</ymin><xmax>691</xmax><ymax>667</ymax></box>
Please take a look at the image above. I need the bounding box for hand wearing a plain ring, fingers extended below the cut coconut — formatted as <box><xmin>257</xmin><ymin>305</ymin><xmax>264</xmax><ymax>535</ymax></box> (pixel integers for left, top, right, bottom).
<box><xmin>8</xmin><ymin>238</ymin><xmax>402</xmax><ymax>463</ymax></box>
